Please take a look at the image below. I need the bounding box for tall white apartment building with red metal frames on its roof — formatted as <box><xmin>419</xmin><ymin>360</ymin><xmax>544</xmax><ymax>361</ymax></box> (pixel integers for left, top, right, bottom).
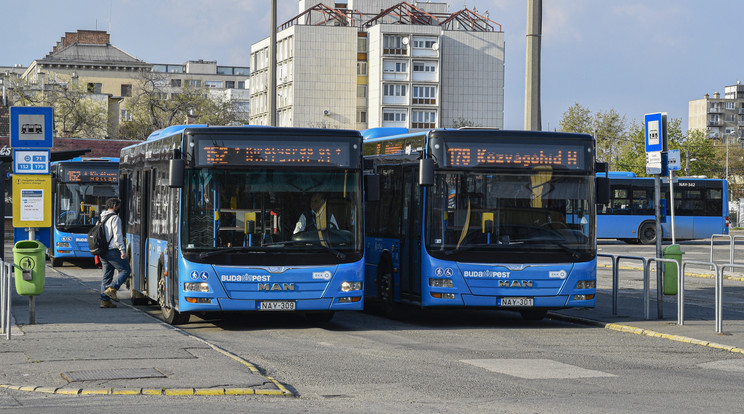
<box><xmin>250</xmin><ymin>0</ymin><xmax>504</xmax><ymax>129</ymax></box>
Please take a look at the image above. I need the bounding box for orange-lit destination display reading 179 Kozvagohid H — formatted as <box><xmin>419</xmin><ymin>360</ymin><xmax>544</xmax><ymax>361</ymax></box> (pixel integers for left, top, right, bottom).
<box><xmin>445</xmin><ymin>142</ymin><xmax>586</xmax><ymax>170</ymax></box>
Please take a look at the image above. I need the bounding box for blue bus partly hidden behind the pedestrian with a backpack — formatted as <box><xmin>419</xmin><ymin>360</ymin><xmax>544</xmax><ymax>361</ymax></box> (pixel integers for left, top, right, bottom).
<box><xmin>47</xmin><ymin>157</ymin><xmax>119</xmax><ymax>267</ymax></box>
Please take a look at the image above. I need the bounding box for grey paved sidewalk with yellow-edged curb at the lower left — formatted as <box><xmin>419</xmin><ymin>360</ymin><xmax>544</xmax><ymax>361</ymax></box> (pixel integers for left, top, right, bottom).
<box><xmin>0</xmin><ymin>267</ymin><xmax>292</xmax><ymax>396</ymax></box>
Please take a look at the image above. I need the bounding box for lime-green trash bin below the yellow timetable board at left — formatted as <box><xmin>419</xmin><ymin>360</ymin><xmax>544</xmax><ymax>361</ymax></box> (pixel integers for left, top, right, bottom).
<box><xmin>13</xmin><ymin>240</ymin><xmax>46</xmax><ymax>296</ymax></box>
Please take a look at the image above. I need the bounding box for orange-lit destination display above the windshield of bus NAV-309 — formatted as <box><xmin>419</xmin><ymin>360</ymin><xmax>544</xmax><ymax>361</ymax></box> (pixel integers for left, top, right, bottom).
<box><xmin>198</xmin><ymin>141</ymin><xmax>358</xmax><ymax>167</ymax></box>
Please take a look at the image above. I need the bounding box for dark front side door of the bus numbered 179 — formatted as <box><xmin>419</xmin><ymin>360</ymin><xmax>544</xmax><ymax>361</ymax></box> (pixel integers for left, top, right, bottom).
<box><xmin>400</xmin><ymin>164</ymin><xmax>423</xmax><ymax>302</ymax></box>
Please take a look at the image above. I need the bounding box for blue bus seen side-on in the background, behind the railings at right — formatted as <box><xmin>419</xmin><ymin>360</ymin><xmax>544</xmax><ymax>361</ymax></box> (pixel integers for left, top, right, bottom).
<box><xmin>597</xmin><ymin>171</ymin><xmax>729</xmax><ymax>244</ymax></box>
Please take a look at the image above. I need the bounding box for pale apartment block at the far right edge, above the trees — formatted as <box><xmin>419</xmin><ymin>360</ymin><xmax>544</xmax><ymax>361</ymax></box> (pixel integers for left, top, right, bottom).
<box><xmin>687</xmin><ymin>82</ymin><xmax>744</xmax><ymax>140</ymax></box>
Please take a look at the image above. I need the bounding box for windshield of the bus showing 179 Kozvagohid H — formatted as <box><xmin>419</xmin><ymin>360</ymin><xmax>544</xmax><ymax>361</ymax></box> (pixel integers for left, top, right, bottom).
<box><xmin>426</xmin><ymin>171</ymin><xmax>595</xmax><ymax>263</ymax></box>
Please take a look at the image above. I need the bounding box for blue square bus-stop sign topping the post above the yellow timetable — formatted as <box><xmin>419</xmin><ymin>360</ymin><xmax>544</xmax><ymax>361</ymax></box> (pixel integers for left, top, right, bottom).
<box><xmin>10</xmin><ymin>106</ymin><xmax>54</xmax><ymax>148</ymax></box>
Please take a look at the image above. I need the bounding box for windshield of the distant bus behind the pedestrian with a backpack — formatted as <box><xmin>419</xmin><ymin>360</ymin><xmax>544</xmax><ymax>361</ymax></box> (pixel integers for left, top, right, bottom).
<box><xmin>56</xmin><ymin>182</ymin><xmax>118</xmax><ymax>233</ymax></box>
